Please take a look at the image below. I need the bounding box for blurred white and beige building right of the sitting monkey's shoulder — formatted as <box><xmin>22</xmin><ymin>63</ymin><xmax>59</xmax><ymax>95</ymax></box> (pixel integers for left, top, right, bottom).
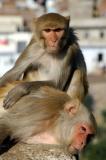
<box><xmin>70</xmin><ymin>18</ymin><xmax>106</xmax><ymax>73</ymax></box>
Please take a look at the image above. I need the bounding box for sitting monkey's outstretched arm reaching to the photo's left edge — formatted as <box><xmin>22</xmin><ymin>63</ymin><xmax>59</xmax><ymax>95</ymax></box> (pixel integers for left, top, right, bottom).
<box><xmin>0</xmin><ymin>41</ymin><xmax>44</xmax><ymax>86</ymax></box>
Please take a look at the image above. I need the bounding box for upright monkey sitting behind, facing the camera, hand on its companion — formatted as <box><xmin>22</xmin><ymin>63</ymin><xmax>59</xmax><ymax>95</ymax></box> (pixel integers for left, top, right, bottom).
<box><xmin>0</xmin><ymin>13</ymin><xmax>88</xmax><ymax>108</ymax></box>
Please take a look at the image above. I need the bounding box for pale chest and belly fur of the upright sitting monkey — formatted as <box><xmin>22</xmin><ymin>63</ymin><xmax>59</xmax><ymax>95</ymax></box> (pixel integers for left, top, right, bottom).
<box><xmin>25</xmin><ymin>58</ymin><xmax>71</xmax><ymax>89</ymax></box>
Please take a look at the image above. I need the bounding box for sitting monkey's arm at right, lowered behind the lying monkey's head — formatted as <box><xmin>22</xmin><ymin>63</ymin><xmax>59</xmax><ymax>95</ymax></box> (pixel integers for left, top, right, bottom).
<box><xmin>67</xmin><ymin>49</ymin><xmax>88</xmax><ymax>101</ymax></box>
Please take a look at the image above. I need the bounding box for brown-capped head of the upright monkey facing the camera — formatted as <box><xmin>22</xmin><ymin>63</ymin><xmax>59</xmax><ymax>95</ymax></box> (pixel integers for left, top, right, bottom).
<box><xmin>34</xmin><ymin>13</ymin><xmax>70</xmax><ymax>54</ymax></box>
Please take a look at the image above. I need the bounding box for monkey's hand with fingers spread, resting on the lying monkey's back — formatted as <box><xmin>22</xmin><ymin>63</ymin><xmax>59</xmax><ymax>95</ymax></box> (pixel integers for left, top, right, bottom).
<box><xmin>3</xmin><ymin>84</ymin><xmax>29</xmax><ymax>109</ymax></box>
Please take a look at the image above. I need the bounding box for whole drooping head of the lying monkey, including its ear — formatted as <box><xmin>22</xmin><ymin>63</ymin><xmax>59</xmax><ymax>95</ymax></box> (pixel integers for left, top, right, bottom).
<box><xmin>58</xmin><ymin>99</ymin><xmax>97</xmax><ymax>154</ymax></box>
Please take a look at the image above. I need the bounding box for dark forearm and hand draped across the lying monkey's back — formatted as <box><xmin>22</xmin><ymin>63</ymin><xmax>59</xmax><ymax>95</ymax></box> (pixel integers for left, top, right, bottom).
<box><xmin>3</xmin><ymin>81</ymin><xmax>55</xmax><ymax>109</ymax></box>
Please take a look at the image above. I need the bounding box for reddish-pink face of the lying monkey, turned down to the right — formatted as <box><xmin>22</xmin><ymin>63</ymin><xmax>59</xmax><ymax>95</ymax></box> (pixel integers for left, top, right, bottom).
<box><xmin>69</xmin><ymin>124</ymin><xmax>94</xmax><ymax>153</ymax></box>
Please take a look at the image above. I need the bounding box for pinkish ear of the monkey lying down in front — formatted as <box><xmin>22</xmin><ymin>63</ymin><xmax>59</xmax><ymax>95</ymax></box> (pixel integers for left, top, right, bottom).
<box><xmin>64</xmin><ymin>99</ymin><xmax>80</xmax><ymax>116</ymax></box>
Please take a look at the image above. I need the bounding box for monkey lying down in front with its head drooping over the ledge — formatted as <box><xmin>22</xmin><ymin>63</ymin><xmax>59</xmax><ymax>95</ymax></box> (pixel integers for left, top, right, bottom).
<box><xmin>0</xmin><ymin>81</ymin><xmax>96</xmax><ymax>154</ymax></box>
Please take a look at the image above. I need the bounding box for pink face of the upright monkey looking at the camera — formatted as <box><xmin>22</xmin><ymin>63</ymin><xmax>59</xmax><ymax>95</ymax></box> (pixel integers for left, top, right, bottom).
<box><xmin>42</xmin><ymin>28</ymin><xmax>64</xmax><ymax>51</ymax></box>
